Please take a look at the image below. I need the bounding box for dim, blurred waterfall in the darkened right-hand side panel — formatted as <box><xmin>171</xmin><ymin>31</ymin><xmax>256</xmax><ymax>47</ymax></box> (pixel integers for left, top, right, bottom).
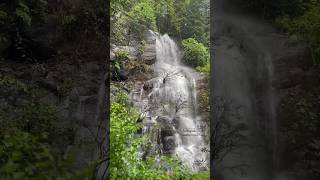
<box><xmin>212</xmin><ymin>0</ymin><xmax>293</xmax><ymax>180</ymax></box>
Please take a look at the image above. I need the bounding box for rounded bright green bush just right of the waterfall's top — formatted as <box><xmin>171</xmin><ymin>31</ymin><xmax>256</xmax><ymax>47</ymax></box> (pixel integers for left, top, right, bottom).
<box><xmin>182</xmin><ymin>38</ymin><xmax>209</xmax><ymax>67</ymax></box>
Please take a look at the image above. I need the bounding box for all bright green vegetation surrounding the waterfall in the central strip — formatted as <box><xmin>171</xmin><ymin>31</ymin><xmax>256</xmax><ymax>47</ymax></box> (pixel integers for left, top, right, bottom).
<box><xmin>110</xmin><ymin>0</ymin><xmax>210</xmax><ymax>179</ymax></box>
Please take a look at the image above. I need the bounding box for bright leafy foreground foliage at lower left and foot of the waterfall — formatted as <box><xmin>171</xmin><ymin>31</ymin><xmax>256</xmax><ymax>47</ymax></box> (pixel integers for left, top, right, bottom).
<box><xmin>110</xmin><ymin>93</ymin><xmax>196</xmax><ymax>180</ymax></box>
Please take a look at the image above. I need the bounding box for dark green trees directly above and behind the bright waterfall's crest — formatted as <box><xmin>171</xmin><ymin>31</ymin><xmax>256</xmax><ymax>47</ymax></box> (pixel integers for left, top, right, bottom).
<box><xmin>153</xmin><ymin>0</ymin><xmax>209</xmax><ymax>46</ymax></box>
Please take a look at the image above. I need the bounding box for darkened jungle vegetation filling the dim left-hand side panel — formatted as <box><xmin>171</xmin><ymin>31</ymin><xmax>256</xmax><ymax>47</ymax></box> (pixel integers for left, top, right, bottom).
<box><xmin>0</xmin><ymin>0</ymin><xmax>108</xmax><ymax>179</ymax></box>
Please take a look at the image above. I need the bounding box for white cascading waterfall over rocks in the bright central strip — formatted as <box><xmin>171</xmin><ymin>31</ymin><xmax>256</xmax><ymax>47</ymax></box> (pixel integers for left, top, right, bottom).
<box><xmin>132</xmin><ymin>32</ymin><xmax>207</xmax><ymax>171</ymax></box>
